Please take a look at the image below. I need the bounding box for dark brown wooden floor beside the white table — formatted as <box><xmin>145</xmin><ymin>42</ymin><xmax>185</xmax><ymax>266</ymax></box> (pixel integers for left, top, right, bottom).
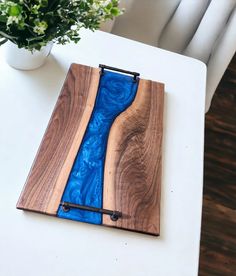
<box><xmin>199</xmin><ymin>55</ymin><xmax>236</xmax><ymax>276</ymax></box>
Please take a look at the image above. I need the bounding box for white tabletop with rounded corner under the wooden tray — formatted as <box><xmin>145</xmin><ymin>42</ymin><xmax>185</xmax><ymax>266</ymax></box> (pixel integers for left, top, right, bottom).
<box><xmin>0</xmin><ymin>31</ymin><xmax>206</xmax><ymax>276</ymax></box>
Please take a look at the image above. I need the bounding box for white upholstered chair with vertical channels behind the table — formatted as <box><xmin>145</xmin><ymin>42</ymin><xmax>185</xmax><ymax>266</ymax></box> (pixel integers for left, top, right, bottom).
<box><xmin>101</xmin><ymin>0</ymin><xmax>236</xmax><ymax>112</ymax></box>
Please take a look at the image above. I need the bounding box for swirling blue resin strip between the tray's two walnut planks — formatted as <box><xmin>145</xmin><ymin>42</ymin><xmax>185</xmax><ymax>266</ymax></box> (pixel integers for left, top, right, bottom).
<box><xmin>57</xmin><ymin>71</ymin><xmax>138</xmax><ymax>224</ymax></box>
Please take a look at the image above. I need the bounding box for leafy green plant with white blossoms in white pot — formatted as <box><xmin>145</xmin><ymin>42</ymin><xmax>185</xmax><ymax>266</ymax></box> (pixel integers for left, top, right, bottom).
<box><xmin>0</xmin><ymin>0</ymin><xmax>122</xmax><ymax>70</ymax></box>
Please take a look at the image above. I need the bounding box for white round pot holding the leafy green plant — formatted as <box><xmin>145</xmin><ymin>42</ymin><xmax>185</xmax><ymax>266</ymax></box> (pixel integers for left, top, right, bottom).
<box><xmin>5</xmin><ymin>41</ymin><xmax>53</xmax><ymax>70</ymax></box>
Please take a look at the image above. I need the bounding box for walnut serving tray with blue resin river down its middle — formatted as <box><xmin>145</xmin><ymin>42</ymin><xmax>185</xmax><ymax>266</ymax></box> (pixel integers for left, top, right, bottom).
<box><xmin>17</xmin><ymin>64</ymin><xmax>164</xmax><ymax>235</ymax></box>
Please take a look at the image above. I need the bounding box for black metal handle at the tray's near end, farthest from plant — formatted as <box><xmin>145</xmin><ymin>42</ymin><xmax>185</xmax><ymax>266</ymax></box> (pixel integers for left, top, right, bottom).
<box><xmin>61</xmin><ymin>201</ymin><xmax>122</xmax><ymax>221</ymax></box>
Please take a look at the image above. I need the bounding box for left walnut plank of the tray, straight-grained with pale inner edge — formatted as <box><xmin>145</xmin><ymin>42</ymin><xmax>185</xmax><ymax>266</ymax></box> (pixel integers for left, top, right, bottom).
<box><xmin>17</xmin><ymin>64</ymin><xmax>99</xmax><ymax>215</ymax></box>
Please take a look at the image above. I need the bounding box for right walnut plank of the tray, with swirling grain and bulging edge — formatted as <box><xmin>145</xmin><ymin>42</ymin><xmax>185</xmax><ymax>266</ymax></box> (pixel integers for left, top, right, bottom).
<box><xmin>103</xmin><ymin>80</ymin><xmax>164</xmax><ymax>235</ymax></box>
